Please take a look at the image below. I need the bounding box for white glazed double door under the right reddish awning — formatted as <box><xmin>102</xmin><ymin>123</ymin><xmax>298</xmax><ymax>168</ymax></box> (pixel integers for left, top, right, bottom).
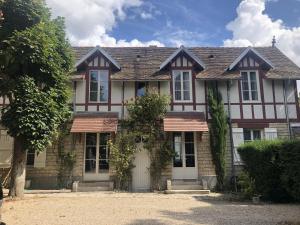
<box><xmin>172</xmin><ymin>132</ymin><xmax>198</xmax><ymax>179</ymax></box>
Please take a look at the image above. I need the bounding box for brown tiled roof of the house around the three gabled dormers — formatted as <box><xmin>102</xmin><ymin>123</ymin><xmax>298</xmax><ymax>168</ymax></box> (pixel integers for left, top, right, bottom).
<box><xmin>73</xmin><ymin>47</ymin><xmax>300</xmax><ymax>80</ymax></box>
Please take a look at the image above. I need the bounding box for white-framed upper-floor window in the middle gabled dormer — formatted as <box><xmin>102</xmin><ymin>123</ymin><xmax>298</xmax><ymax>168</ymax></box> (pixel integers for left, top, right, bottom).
<box><xmin>173</xmin><ymin>70</ymin><xmax>192</xmax><ymax>102</ymax></box>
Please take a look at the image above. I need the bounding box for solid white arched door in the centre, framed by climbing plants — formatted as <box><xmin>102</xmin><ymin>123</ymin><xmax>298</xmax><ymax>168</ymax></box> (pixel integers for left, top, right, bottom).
<box><xmin>132</xmin><ymin>143</ymin><xmax>150</xmax><ymax>192</ymax></box>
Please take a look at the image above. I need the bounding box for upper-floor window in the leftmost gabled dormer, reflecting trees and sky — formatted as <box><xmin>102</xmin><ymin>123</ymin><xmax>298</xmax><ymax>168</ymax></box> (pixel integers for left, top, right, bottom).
<box><xmin>89</xmin><ymin>70</ymin><xmax>108</xmax><ymax>102</ymax></box>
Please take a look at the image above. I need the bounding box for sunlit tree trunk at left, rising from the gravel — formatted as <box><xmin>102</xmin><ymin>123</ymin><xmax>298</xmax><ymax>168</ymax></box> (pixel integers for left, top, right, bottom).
<box><xmin>8</xmin><ymin>137</ymin><xmax>26</xmax><ymax>198</ymax></box>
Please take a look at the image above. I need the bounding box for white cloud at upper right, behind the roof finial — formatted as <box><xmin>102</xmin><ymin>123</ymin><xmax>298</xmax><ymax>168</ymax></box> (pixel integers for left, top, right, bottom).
<box><xmin>224</xmin><ymin>0</ymin><xmax>300</xmax><ymax>66</ymax></box>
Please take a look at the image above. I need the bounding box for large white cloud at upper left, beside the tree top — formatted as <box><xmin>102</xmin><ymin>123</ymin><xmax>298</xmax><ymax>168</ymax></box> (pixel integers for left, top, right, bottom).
<box><xmin>46</xmin><ymin>0</ymin><xmax>162</xmax><ymax>46</ymax></box>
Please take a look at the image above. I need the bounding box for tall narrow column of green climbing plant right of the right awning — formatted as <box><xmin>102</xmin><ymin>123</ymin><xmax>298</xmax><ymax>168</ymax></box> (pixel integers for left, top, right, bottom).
<box><xmin>208</xmin><ymin>86</ymin><xmax>227</xmax><ymax>190</ymax></box>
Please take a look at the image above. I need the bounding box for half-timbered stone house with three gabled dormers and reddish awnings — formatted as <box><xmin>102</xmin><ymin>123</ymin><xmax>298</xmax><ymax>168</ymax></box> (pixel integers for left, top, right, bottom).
<box><xmin>0</xmin><ymin>46</ymin><xmax>300</xmax><ymax>190</ymax></box>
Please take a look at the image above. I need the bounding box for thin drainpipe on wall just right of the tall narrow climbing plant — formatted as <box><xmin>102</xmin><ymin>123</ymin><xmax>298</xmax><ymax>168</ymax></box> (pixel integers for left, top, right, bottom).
<box><xmin>227</xmin><ymin>80</ymin><xmax>237</xmax><ymax>192</ymax></box>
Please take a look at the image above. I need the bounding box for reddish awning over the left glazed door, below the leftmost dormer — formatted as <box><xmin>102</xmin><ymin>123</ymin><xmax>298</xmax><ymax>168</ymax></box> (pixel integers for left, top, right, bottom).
<box><xmin>71</xmin><ymin>113</ymin><xmax>118</xmax><ymax>133</ymax></box>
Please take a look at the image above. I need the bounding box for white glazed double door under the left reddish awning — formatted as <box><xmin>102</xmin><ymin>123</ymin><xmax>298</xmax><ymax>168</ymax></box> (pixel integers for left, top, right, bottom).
<box><xmin>83</xmin><ymin>133</ymin><xmax>110</xmax><ymax>181</ymax></box>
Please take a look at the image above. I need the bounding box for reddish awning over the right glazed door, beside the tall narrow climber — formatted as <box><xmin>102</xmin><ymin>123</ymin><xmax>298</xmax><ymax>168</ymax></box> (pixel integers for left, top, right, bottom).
<box><xmin>164</xmin><ymin>112</ymin><xmax>208</xmax><ymax>132</ymax></box>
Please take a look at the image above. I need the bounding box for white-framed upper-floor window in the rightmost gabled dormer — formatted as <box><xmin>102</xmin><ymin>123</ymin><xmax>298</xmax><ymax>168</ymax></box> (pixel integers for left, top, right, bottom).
<box><xmin>241</xmin><ymin>71</ymin><xmax>259</xmax><ymax>101</ymax></box>
